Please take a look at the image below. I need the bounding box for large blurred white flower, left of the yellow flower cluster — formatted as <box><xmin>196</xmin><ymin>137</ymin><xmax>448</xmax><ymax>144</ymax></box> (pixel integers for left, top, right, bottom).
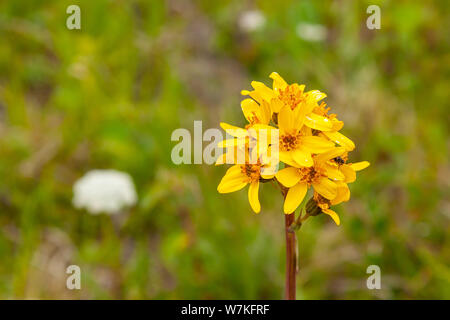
<box><xmin>72</xmin><ymin>170</ymin><xmax>137</xmax><ymax>214</ymax></box>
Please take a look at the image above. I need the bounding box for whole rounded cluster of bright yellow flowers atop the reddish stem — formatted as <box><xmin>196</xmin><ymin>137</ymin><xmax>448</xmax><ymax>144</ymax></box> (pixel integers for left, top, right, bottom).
<box><xmin>216</xmin><ymin>72</ymin><xmax>369</xmax><ymax>225</ymax></box>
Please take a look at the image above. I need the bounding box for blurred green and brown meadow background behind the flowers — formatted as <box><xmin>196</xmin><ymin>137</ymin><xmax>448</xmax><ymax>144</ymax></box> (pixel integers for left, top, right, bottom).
<box><xmin>0</xmin><ymin>0</ymin><xmax>450</xmax><ymax>299</ymax></box>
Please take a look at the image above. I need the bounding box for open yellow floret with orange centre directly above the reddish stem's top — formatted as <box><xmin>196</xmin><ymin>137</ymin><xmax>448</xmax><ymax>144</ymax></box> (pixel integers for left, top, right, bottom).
<box><xmin>275</xmin><ymin>147</ymin><xmax>345</xmax><ymax>213</ymax></box>
